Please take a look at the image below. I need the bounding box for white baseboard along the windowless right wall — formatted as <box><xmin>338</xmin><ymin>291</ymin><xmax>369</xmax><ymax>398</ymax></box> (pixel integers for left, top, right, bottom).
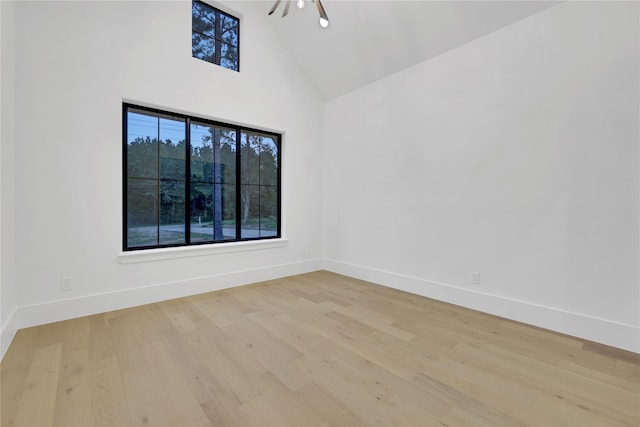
<box><xmin>324</xmin><ymin>259</ymin><xmax>640</xmax><ymax>353</ymax></box>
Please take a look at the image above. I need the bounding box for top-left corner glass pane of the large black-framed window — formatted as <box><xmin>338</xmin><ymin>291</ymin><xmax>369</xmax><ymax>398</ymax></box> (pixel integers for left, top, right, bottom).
<box><xmin>127</xmin><ymin>110</ymin><xmax>158</xmax><ymax>178</ymax></box>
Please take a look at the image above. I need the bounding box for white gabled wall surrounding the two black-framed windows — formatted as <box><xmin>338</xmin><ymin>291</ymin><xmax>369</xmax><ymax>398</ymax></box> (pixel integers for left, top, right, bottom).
<box><xmin>3</xmin><ymin>1</ymin><xmax>322</xmax><ymax>358</ymax></box>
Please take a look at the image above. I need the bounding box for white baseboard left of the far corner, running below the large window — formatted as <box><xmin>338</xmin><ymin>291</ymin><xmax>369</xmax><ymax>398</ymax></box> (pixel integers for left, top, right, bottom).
<box><xmin>0</xmin><ymin>259</ymin><xmax>322</xmax><ymax>360</ymax></box>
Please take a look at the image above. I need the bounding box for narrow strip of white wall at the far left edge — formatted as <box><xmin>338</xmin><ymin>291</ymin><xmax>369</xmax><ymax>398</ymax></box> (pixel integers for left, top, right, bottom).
<box><xmin>0</xmin><ymin>1</ymin><xmax>16</xmax><ymax>357</ymax></box>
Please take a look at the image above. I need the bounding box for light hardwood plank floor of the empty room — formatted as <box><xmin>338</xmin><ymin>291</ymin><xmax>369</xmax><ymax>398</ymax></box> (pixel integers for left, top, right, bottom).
<box><xmin>0</xmin><ymin>272</ymin><xmax>640</xmax><ymax>427</ymax></box>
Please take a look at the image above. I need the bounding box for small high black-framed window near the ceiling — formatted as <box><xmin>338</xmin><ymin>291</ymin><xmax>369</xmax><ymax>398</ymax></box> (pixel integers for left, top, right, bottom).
<box><xmin>191</xmin><ymin>0</ymin><xmax>240</xmax><ymax>71</ymax></box>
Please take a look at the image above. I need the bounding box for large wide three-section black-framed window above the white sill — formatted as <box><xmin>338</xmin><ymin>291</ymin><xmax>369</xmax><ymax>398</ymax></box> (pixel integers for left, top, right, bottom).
<box><xmin>123</xmin><ymin>103</ymin><xmax>281</xmax><ymax>251</ymax></box>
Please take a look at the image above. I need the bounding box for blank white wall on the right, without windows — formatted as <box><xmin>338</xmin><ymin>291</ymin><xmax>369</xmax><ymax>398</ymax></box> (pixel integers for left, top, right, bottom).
<box><xmin>324</xmin><ymin>2</ymin><xmax>640</xmax><ymax>352</ymax></box>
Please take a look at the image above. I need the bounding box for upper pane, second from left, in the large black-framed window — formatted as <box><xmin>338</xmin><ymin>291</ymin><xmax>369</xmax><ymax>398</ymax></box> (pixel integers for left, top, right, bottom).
<box><xmin>160</xmin><ymin>117</ymin><xmax>186</xmax><ymax>180</ymax></box>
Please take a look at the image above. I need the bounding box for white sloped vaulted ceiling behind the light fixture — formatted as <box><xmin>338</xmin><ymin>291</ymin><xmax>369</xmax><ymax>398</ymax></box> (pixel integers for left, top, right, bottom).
<box><xmin>258</xmin><ymin>0</ymin><xmax>558</xmax><ymax>100</ymax></box>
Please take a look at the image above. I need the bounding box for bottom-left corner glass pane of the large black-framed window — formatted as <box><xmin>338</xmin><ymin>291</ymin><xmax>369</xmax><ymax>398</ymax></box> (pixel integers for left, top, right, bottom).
<box><xmin>127</xmin><ymin>178</ymin><xmax>158</xmax><ymax>248</ymax></box>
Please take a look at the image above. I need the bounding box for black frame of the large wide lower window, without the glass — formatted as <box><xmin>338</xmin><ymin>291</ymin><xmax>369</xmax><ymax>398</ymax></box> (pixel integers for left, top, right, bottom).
<box><xmin>122</xmin><ymin>102</ymin><xmax>283</xmax><ymax>253</ymax></box>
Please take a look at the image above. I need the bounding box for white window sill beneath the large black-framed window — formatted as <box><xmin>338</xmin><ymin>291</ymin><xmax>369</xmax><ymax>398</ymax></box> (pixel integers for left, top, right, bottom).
<box><xmin>118</xmin><ymin>238</ymin><xmax>289</xmax><ymax>264</ymax></box>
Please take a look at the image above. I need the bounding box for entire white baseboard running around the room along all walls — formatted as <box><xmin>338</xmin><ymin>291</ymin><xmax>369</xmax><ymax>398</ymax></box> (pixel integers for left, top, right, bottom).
<box><xmin>0</xmin><ymin>259</ymin><xmax>640</xmax><ymax>360</ymax></box>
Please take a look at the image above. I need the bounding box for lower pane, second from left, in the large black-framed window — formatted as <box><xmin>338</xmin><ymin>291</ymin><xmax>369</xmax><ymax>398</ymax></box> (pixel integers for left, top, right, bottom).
<box><xmin>160</xmin><ymin>180</ymin><xmax>186</xmax><ymax>245</ymax></box>
